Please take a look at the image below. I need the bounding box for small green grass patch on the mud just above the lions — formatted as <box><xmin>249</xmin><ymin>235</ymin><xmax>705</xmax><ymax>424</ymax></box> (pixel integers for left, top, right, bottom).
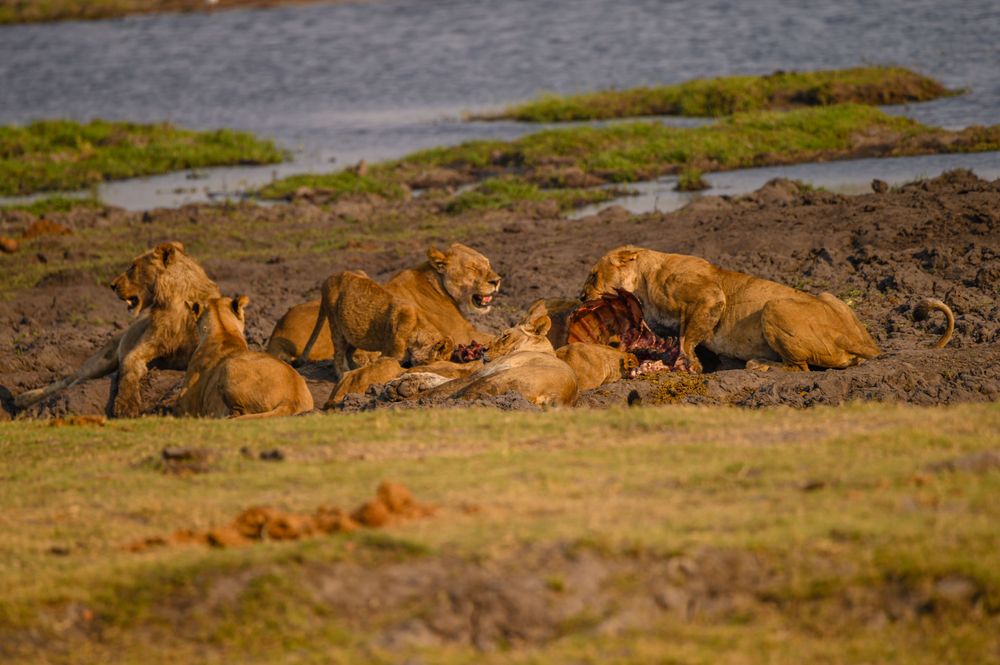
<box><xmin>445</xmin><ymin>177</ymin><xmax>621</xmax><ymax>214</ymax></box>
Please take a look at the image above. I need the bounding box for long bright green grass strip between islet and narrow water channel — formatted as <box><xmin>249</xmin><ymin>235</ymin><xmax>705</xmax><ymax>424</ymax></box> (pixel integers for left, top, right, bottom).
<box><xmin>402</xmin><ymin>104</ymin><xmax>1000</xmax><ymax>182</ymax></box>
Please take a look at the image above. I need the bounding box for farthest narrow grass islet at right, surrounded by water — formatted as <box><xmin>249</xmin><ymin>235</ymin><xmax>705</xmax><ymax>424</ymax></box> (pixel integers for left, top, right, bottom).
<box><xmin>486</xmin><ymin>66</ymin><xmax>960</xmax><ymax>122</ymax></box>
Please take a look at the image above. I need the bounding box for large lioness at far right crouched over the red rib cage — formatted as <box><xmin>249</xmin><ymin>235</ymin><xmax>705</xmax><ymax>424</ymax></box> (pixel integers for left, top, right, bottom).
<box><xmin>581</xmin><ymin>245</ymin><xmax>952</xmax><ymax>372</ymax></box>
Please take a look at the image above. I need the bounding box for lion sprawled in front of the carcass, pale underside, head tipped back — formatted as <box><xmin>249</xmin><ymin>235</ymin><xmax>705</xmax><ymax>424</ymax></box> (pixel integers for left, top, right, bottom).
<box><xmin>386</xmin><ymin>307</ymin><xmax>578</xmax><ymax>406</ymax></box>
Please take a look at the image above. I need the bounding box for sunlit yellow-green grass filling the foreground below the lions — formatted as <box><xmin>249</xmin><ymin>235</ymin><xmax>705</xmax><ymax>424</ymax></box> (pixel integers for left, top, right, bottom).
<box><xmin>0</xmin><ymin>405</ymin><xmax>1000</xmax><ymax>663</ymax></box>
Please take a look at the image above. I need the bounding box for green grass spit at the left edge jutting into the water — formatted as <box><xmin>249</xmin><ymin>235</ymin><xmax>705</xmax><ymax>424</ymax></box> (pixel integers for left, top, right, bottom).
<box><xmin>0</xmin><ymin>120</ymin><xmax>285</xmax><ymax>196</ymax></box>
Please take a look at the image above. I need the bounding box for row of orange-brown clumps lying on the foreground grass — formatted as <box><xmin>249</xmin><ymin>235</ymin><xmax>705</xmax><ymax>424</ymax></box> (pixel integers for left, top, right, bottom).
<box><xmin>125</xmin><ymin>481</ymin><xmax>437</xmax><ymax>552</ymax></box>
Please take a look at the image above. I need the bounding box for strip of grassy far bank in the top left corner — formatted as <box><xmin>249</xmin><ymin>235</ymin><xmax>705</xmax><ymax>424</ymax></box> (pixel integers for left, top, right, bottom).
<box><xmin>0</xmin><ymin>0</ymin><xmax>336</xmax><ymax>25</ymax></box>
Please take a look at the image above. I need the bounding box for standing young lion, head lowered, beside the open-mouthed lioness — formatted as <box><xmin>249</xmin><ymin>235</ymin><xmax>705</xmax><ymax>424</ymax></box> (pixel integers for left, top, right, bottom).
<box><xmin>295</xmin><ymin>271</ymin><xmax>455</xmax><ymax>379</ymax></box>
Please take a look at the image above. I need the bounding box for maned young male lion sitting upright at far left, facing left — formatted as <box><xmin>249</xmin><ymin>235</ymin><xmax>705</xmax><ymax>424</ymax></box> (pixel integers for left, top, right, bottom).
<box><xmin>15</xmin><ymin>242</ymin><xmax>220</xmax><ymax>418</ymax></box>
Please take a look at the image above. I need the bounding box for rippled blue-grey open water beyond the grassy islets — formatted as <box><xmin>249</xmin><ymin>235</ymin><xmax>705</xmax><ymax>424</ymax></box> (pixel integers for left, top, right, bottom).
<box><xmin>0</xmin><ymin>0</ymin><xmax>1000</xmax><ymax>207</ymax></box>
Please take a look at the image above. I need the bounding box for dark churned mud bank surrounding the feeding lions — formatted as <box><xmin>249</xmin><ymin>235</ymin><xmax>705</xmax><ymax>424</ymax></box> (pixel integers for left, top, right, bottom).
<box><xmin>0</xmin><ymin>171</ymin><xmax>1000</xmax><ymax>416</ymax></box>
